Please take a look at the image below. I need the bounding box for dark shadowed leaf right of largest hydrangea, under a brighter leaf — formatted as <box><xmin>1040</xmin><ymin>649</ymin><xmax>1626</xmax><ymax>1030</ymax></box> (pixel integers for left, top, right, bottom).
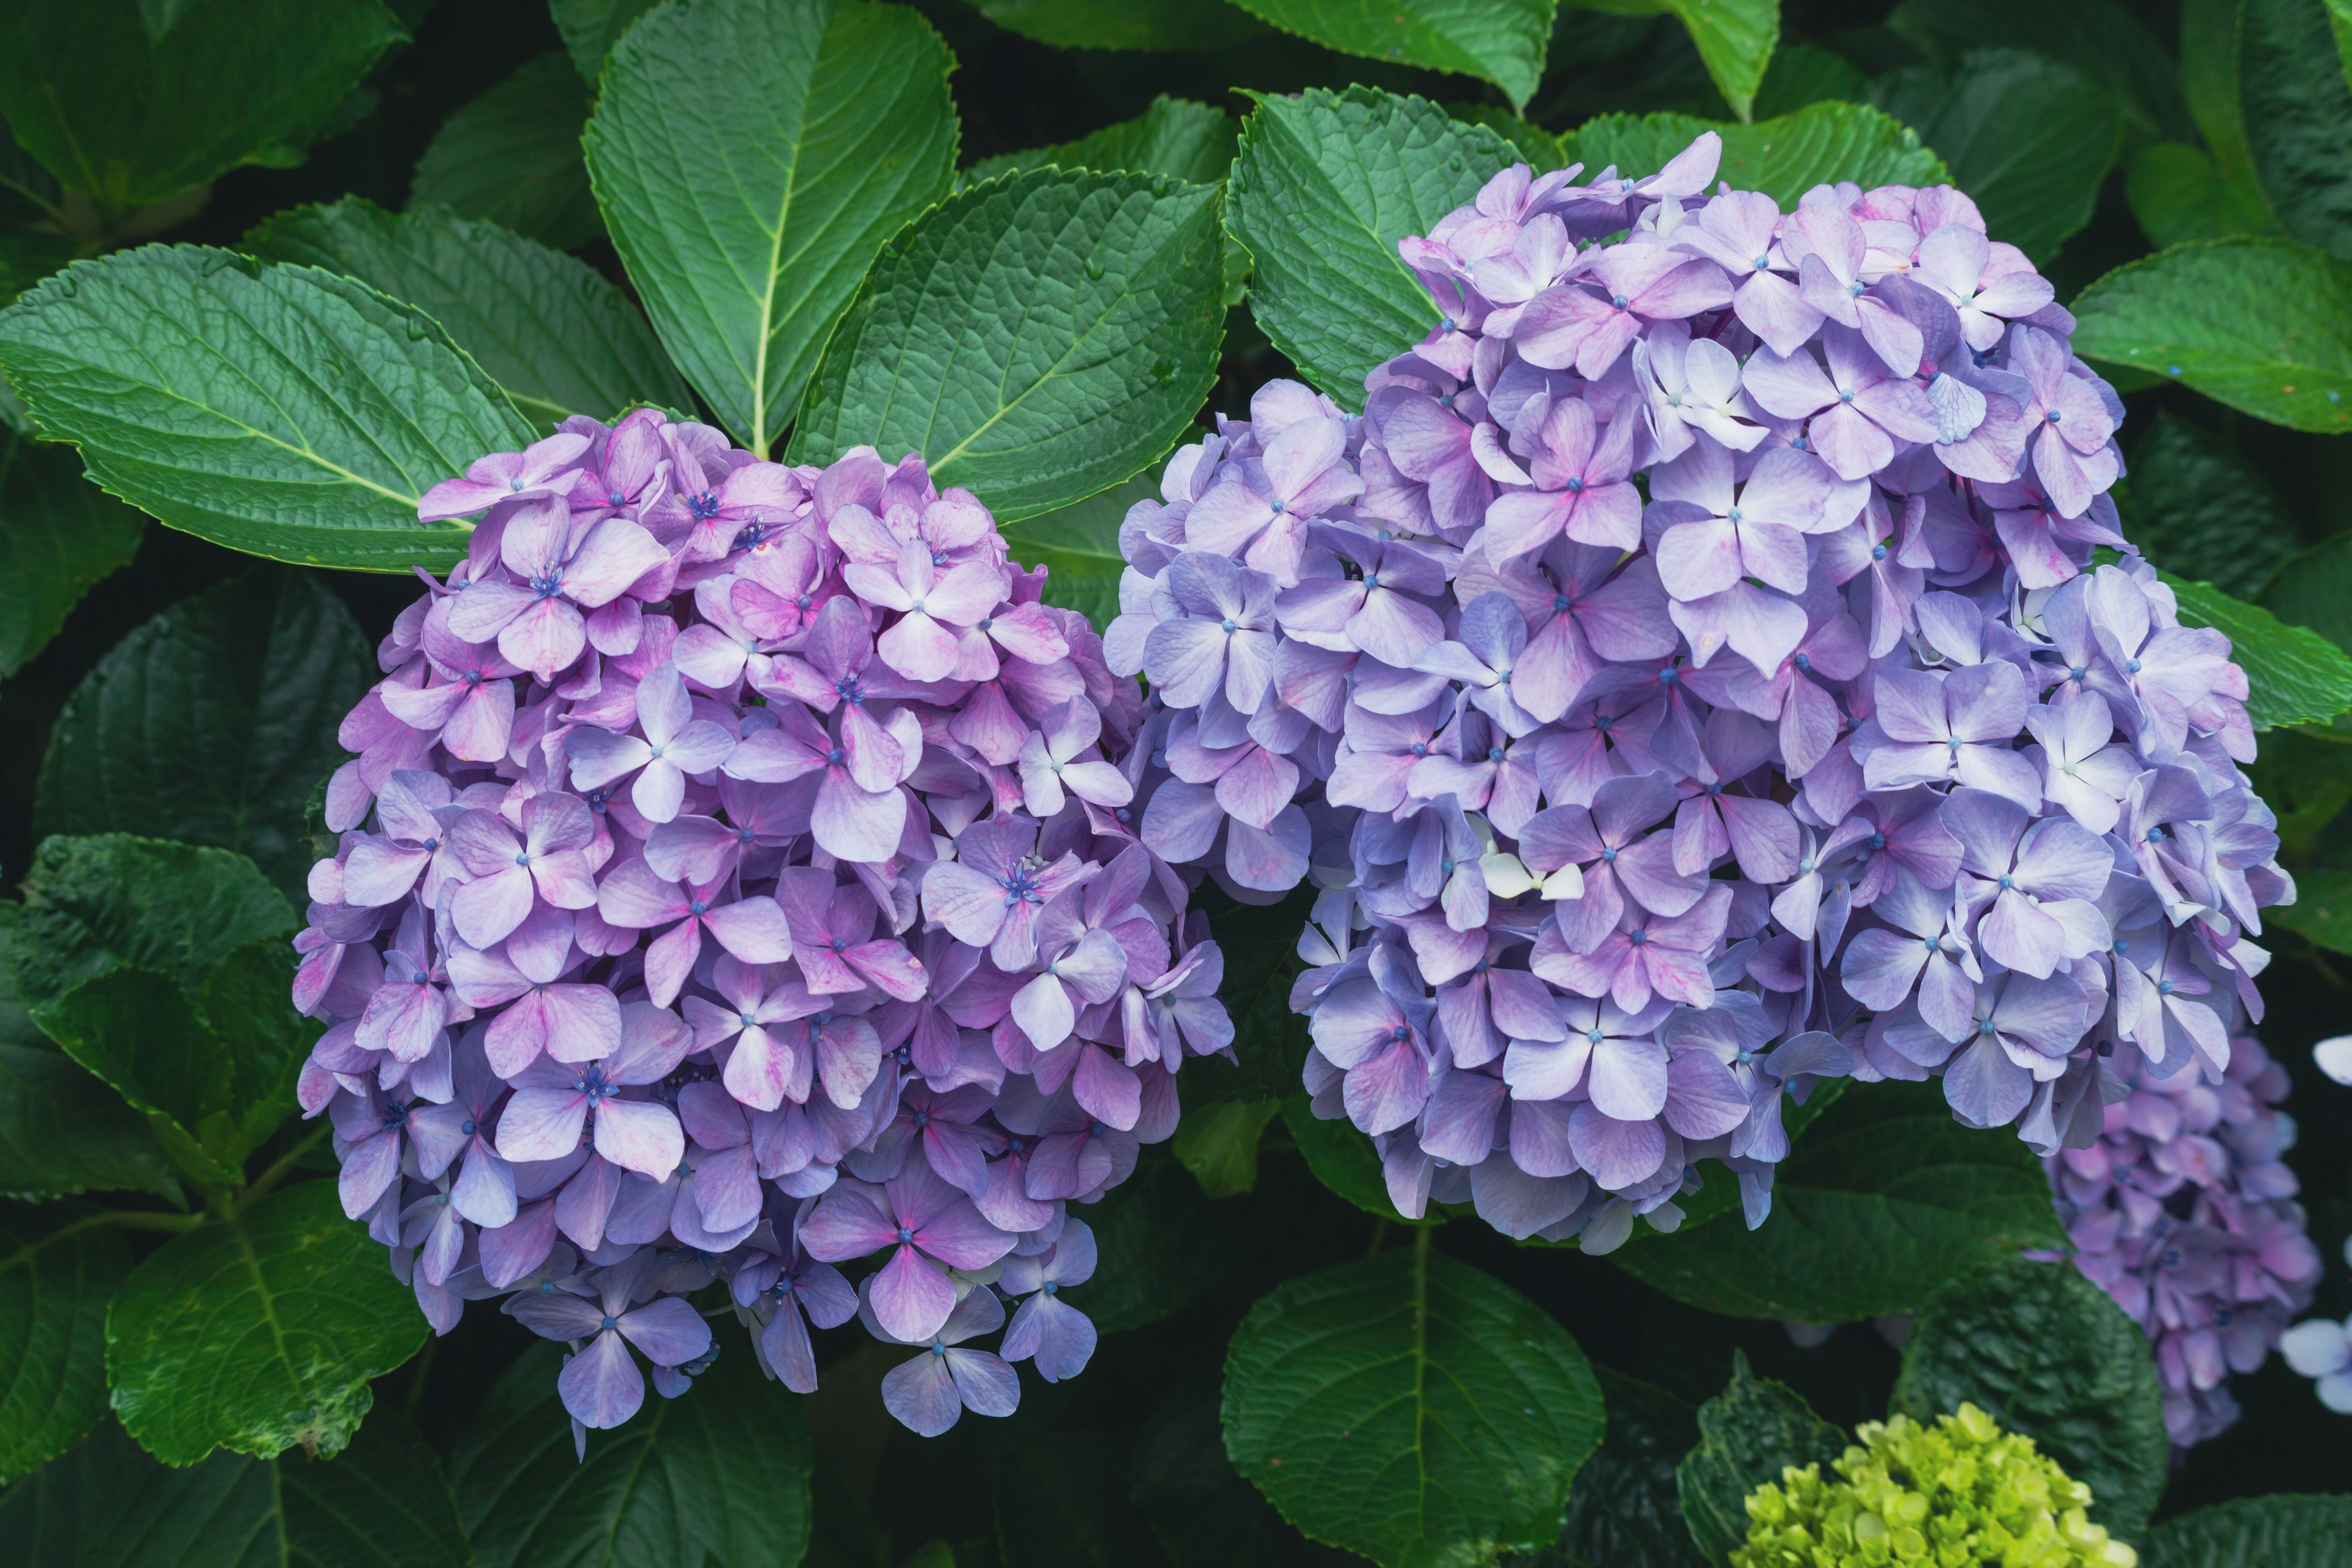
<box><xmin>2114</xmin><ymin>412</ymin><xmax>2310</xmax><ymax>595</ymax></box>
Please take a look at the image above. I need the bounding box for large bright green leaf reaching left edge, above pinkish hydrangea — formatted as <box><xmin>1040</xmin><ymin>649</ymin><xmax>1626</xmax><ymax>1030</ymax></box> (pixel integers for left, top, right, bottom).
<box><xmin>0</xmin><ymin>244</ymin><xmax>532</xmax><ymax>571</ymax></box>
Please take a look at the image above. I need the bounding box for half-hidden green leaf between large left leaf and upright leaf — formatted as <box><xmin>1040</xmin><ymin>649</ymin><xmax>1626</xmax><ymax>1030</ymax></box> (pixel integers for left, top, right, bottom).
<box><xmin>244</xmin><ymin>195</ymin><xmax>694</xmax><ymax>428</ymax></box>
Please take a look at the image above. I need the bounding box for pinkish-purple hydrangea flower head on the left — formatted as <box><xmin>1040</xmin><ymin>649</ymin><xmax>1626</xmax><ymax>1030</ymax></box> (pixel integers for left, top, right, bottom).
<box><xmin>294</xmin><ymin>409</ymin><xmax>1232</xmax><ymax>1434</ymax></box>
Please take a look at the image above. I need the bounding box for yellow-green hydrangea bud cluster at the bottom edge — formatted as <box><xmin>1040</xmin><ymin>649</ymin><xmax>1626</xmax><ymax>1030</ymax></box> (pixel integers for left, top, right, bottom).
<box><xmin>1731</xmin><ymin>1403</ymin><xmax>2138</xmax><ymax>1568</ymax></box>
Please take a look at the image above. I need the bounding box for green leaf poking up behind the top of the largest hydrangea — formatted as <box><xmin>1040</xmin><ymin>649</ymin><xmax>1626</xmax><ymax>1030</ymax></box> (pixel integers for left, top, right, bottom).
<box><xmin>1562</xmin><ymin>104</ymin><xmax>1948</xmax><ymax>209</ymax></box>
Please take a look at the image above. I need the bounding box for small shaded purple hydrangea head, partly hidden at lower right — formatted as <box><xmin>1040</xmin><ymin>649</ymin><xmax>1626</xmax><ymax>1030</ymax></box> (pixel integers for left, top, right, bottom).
<box><xmin>2046</xmin><ymin>1035</ymin><xmax>2319</xmax><ymax>1448</ymax></box>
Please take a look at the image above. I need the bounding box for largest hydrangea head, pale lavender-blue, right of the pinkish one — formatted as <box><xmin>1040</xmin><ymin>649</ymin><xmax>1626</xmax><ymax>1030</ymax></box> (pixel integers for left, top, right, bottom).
<box><xmin>1106</xmin><ymin>134</ymin><xmax>2293</xmax><ymax>1251</ymax></box>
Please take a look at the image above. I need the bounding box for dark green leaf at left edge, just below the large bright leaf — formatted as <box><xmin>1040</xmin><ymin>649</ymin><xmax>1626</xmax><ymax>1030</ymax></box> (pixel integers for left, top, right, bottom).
<box><xmin>0</xmin><ymin>430</ymin><xmax>146</xmax><ymax>677</ymax></box>
